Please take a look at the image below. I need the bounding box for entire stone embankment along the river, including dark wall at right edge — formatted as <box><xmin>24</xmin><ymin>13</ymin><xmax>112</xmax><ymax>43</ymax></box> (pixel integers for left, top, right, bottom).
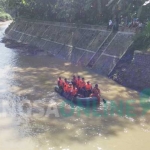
<box><xmin>6</xmin><ymin>20</ymin><xmax>150</xmax><ymax>89</ymax></box>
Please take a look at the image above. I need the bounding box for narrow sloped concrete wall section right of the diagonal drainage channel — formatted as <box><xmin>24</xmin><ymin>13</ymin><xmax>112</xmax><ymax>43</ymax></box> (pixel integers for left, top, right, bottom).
<box><xmin>93</xmin><ymin>32</ymin><xmax>134</xmax><ymax>75</ymax></box>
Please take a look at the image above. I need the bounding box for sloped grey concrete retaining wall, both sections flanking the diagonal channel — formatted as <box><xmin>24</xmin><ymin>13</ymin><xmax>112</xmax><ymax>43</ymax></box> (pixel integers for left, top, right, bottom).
<box><xmin>6</xmin><ymin>20</ymin><xmax>134</xmax><ymax>75</ymax></box>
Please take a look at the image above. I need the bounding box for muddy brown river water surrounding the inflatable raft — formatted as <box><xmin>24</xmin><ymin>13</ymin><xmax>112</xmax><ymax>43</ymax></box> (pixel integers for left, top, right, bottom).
<box><xmin>0</xmin><ymin>22</ymin><xmax>150</xmax><ymax>150</ymax></box>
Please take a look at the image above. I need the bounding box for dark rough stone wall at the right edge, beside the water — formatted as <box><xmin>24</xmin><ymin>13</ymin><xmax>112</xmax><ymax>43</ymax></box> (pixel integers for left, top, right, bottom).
<box><xmin>113</xmin><ymin>51</ymin><xmax>150</xmax><ymax>90</ymax></box>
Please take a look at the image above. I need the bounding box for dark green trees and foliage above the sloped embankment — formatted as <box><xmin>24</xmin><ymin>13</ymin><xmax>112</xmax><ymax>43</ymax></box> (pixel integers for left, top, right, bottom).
<box><xmin>6</xmin><ymin>0</ymin><xmax>150</xmax><ymax>24</ymax></box>
